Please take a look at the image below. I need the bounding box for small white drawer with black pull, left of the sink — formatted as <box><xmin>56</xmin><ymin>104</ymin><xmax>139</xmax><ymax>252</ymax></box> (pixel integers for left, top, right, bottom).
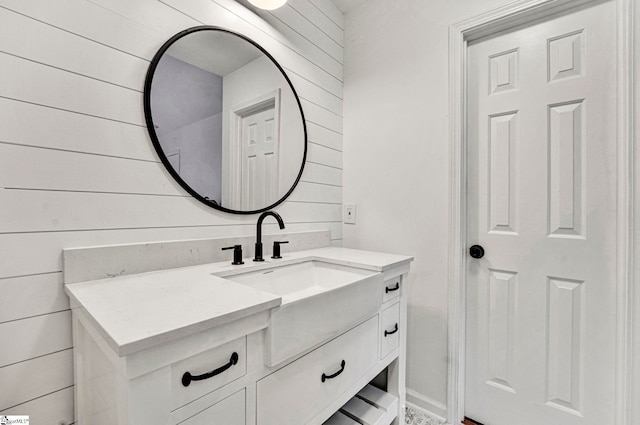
<box><xmin>171</xmin><ymin>337</ymin><xmax>247</xmax><ymax>410</ymax></box>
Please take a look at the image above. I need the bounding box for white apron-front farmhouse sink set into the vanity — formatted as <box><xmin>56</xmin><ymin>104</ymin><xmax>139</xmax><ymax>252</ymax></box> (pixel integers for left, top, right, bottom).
<box><xmin>220</xmin><ymin>260</ymin><xmax>383</xmax><ymax>366</ymax></box>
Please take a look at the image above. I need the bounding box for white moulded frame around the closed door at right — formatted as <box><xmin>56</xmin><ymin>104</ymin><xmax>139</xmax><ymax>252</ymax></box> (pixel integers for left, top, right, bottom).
<box><xmin>447</xmin><ymin>0</ymin><xmax>640</xmax><ymax>425</ymax></box>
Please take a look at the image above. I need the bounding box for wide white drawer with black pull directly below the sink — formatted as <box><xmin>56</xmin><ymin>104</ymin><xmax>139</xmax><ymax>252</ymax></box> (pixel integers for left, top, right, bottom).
<box><xmin>257</xmin><ymin>316</ymin><xmax>378</xmax><ymax>425</ymax></box>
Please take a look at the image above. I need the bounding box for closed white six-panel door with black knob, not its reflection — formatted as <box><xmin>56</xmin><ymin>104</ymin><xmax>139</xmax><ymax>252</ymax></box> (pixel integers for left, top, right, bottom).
<box><xmin>465</xmin><ymin>1</ymin><xmax>616</xmax><ymax>425</ymax></box>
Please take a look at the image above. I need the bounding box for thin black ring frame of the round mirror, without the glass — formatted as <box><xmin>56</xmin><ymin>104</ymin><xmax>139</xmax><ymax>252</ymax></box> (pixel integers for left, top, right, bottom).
<box><xmin>143</xmin><ymin>25</ymin><xmax>308</xmax><ymax>214</ymax></box>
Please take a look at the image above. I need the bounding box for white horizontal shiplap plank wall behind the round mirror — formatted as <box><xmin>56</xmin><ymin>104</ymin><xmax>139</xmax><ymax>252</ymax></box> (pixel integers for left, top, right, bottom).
<box><xmin>0</xmin><ymin>0</ymin><xmax>344</xmax><ymax>424</ymax></box>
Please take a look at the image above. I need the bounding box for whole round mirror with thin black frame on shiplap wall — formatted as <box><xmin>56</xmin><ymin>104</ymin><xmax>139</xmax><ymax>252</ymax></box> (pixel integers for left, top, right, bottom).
<box><xmin>144</xmin><ymin>26</ymin><xmax>307</xmax><ymax>214</ymax></box>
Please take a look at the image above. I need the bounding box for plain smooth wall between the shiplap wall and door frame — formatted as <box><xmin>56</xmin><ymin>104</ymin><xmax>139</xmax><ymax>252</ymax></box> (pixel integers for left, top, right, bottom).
<box><xmin>343</xmin><ymin>0</ymin><xmax>528</xmax><ymax>415</ymax></box>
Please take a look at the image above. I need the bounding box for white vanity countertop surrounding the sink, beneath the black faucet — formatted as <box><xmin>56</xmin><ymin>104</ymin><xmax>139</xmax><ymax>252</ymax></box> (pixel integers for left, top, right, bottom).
<box><xmin>65</xmin><ymin>247</ymin><xmax>413</xmax><ymax>356</ymax></box>
